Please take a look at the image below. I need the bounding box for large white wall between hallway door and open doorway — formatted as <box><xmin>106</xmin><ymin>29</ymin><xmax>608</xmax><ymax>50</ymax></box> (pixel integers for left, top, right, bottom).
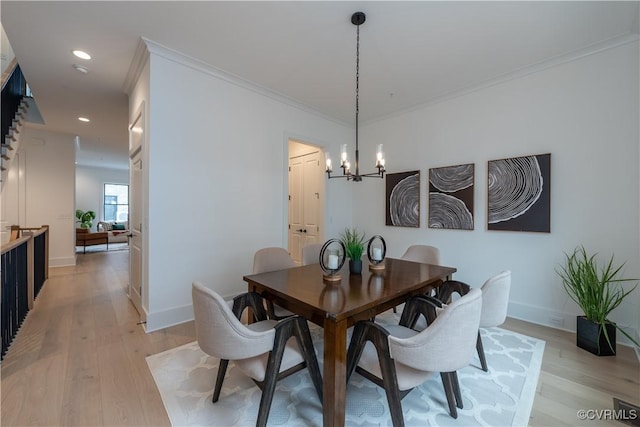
<box><xmin>132</xmin><ymin>43</ymin><xmax>353</xmax><ymax>330</ymax></box>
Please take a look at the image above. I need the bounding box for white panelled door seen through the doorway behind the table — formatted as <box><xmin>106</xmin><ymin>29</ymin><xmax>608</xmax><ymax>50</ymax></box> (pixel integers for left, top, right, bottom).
<box><xmin>288</xmin><ymin>149</ymin><xmax>324</xmax><ymax>264</ymax></box>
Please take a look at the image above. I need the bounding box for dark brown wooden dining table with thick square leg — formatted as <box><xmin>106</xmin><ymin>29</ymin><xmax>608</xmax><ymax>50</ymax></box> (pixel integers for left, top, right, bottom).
<box><xmin>243</xmin><ymin>258</ymin><xmax>456</xmax><ymax>426</ymax></box>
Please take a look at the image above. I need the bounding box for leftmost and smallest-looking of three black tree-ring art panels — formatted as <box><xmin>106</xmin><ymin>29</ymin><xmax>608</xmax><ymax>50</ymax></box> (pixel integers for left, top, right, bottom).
<box><xmin>386</xmin><ymin>171</ymin><xmax>420</xmax><ymax>227</ymax></box>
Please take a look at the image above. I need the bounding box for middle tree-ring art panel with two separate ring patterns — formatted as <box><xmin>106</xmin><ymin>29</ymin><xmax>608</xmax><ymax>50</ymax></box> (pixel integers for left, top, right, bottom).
<box><xmin>427</xmin><ymin>163</ymin><xmax>475</xmax><ymax>230</ymax></box>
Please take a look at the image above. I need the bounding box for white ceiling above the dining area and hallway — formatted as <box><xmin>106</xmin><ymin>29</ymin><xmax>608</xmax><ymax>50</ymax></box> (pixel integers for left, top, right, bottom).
<box><xmin>0</xmin><ymin>0</ymin><xmax>639</xmax><ymax>168</ymax></box>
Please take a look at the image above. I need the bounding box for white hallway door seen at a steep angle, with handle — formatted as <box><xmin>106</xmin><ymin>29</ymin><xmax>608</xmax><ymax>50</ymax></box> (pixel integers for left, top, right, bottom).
<box><xmin>129</xmin><ymin>115</ymin><xmax>146</xmax><ymax>321</ymax></box>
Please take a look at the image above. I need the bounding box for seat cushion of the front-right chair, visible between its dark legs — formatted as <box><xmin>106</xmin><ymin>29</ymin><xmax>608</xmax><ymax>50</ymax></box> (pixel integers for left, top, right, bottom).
<box><xmin>358</xmin><ymin>325</ymin><xmax>433</xmax><ymax>390</ymax></box>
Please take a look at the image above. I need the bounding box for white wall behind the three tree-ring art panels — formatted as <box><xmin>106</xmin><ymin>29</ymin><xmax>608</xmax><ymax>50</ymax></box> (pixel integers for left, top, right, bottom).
<box><xmin>352</xmin><ymin>42</ymin><xmax>640</xmax><ymax>344</ymax></box>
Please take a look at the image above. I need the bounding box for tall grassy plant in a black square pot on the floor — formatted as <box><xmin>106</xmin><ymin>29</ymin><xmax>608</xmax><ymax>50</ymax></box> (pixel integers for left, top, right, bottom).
<box><xmin>556</xmin><ymin>246</ymin><xmax>640</xmax><ymax>356</ymax></box>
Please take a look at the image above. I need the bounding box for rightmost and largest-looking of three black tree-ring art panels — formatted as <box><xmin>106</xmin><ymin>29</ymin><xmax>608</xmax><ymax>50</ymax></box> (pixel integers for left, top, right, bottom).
<box><xmin>487</xmin><ymin>154</ymin><xmax>551</xmax><ymax>233</ymax></box>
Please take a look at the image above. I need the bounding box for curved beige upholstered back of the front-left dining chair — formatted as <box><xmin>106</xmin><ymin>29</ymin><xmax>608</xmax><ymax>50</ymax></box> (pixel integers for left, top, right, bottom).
<box><xmin>191</xmin><ymin>282</ymin><xmax>275</xmax><ymax>360</ymax></box>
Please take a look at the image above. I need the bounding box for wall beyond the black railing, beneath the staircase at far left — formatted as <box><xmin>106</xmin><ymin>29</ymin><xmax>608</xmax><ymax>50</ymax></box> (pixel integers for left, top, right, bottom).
<box><xmin>2</xmin><ymin>126</ymin><xmax>75</xmax><ymax>267</ymax></box>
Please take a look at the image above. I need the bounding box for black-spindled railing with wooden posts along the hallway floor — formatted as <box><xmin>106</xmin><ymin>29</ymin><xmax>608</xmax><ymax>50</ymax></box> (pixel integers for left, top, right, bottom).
<box><xmin>0</xmin><ymin>225</ymin><xmax>49</xmax><ymax>359</ymax></box>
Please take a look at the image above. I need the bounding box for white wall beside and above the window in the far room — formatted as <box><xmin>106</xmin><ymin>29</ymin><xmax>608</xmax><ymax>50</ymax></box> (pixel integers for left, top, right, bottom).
<box><xmin>74</xmin><ymin>166</ymin><xmax>129</xmax><ymax>231</ymax></box>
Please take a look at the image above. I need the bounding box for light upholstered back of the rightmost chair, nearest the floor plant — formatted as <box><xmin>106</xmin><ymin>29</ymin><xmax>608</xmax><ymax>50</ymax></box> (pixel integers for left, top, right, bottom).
<box><xmin>480</xmin><ymin>270</ymin><xmax>511</xmax><ymax>328</ymax></box>
